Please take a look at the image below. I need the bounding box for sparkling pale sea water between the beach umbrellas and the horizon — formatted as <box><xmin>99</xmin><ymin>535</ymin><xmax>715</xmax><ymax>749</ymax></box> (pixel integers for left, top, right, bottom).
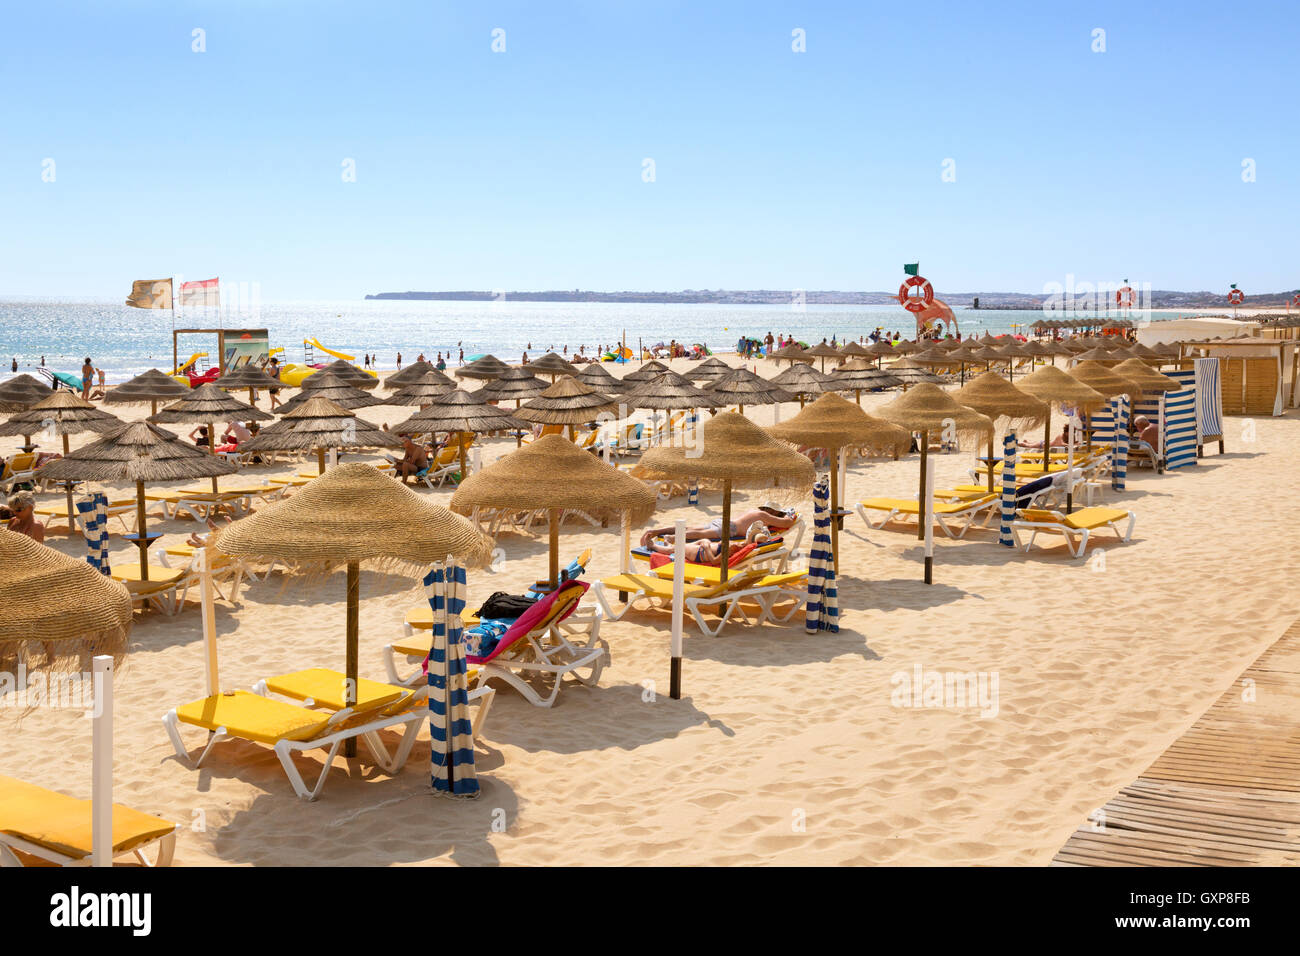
<box><xmin>0</xmin><ymin>299</ymin><xmax>1177</xmax><ymax>384</ymax></box>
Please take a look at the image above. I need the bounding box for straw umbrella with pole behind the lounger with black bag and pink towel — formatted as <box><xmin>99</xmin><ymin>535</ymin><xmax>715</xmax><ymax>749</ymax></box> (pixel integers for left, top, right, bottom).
<box><xmin>451</xmin><ymin>434</ymin><xmax>657</xmax><ymax>587</ymax></box>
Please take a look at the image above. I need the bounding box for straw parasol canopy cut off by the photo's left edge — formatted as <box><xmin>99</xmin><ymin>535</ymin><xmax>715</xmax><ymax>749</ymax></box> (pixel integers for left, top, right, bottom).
<box><xmin>0</xmin><ymin>529</ymin><xmax>131</xmax><ymax>674</ymax></box>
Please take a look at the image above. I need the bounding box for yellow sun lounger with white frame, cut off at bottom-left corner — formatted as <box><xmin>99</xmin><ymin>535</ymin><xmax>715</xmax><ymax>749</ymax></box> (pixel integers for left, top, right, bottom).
<box><xmin>0</xmin><ymin>777</ymin><xmax>179</xmax><ymax>866</ymax></box>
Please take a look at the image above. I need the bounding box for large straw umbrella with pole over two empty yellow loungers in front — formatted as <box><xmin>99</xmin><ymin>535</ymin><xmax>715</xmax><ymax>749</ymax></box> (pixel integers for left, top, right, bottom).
<box><xmin>216</xmin><ymin>463</ymin><xmax>491</xmax><ymax>757</ymax></box>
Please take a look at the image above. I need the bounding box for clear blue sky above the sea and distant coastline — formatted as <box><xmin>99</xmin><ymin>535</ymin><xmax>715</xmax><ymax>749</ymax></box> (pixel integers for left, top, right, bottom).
<box><xmin>0</xmin><ymin>0</ymin><xmax>1300</xmax><ymax>300</ymax></box>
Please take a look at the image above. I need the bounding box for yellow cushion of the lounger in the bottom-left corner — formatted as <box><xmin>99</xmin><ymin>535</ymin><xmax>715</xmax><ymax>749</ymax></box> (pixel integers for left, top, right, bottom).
<box><xmin>0</xmin><ymin>777</ymin><xmax>176</xmax><ymax>860</ymax></box>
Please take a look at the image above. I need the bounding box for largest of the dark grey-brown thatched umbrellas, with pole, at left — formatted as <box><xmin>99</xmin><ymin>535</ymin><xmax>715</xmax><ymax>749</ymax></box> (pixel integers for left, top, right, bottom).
<box><xmin>36</xmin><ymin>421</ymin><xmax>237</xmax><ymax>581</ymax></box>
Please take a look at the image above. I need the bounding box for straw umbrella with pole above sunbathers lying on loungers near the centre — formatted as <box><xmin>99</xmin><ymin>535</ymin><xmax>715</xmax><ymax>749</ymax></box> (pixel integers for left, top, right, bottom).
<box><xmin>632</xmin><ymin>411</ymin><xmax>816</xmax><ymax>583</ymax></box>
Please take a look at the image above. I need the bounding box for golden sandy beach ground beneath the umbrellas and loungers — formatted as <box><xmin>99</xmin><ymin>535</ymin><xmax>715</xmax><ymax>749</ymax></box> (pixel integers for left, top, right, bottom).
<box><xmin>0</xmin><ymin>356</ymin><xmax>1300</xmax><ymax>866</ymax></box>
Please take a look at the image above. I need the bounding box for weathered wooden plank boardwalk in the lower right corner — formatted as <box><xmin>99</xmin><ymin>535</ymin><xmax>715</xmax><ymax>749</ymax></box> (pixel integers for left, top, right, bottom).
<box><xmin>1052</xmin><ymin>622</ymin><xmax>1300</xmax><ymax>866</ymax></box>
